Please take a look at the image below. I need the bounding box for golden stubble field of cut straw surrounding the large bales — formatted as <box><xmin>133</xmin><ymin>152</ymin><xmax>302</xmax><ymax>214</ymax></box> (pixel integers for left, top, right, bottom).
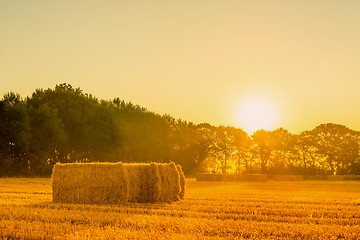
<box><xmin>0</xmin><ymin>178</ymin><xmax>360</xmax><ymax>239</ymax></box>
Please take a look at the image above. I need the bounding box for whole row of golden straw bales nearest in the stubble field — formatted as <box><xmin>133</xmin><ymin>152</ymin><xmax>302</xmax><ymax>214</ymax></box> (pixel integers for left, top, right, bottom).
<box><xmin>52</xmin><ymin>163</ymin><xmax>185</xmax><ymax>204</ymax></box>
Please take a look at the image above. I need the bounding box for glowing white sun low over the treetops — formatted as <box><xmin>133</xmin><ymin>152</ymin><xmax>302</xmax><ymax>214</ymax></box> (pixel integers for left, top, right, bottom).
<box><xmin>238</xmin><ymin>97</ymin><xmax>277</xmax><ymax>134</ymax></box>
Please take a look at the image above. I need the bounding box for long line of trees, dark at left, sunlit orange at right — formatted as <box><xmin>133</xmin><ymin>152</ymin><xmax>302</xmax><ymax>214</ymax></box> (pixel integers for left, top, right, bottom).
<box><xmin>0</xmin><ymin>83</ymin><xmax>360</xmax><ymax>176</ymax></box>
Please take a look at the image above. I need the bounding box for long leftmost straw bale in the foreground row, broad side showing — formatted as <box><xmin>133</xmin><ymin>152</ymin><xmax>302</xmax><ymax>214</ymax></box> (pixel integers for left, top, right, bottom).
<box><xmin>52</xmin><ymin>163</ymin><xmax>129</xmax><ymax>204</ymax></box>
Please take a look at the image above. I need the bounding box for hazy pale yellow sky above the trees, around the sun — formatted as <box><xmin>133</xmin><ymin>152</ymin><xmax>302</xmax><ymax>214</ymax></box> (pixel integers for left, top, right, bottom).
<box><xmin>0</xmin><ymin>0</ymin><xmax>360</xmax><ymax>133</ymax></box>
